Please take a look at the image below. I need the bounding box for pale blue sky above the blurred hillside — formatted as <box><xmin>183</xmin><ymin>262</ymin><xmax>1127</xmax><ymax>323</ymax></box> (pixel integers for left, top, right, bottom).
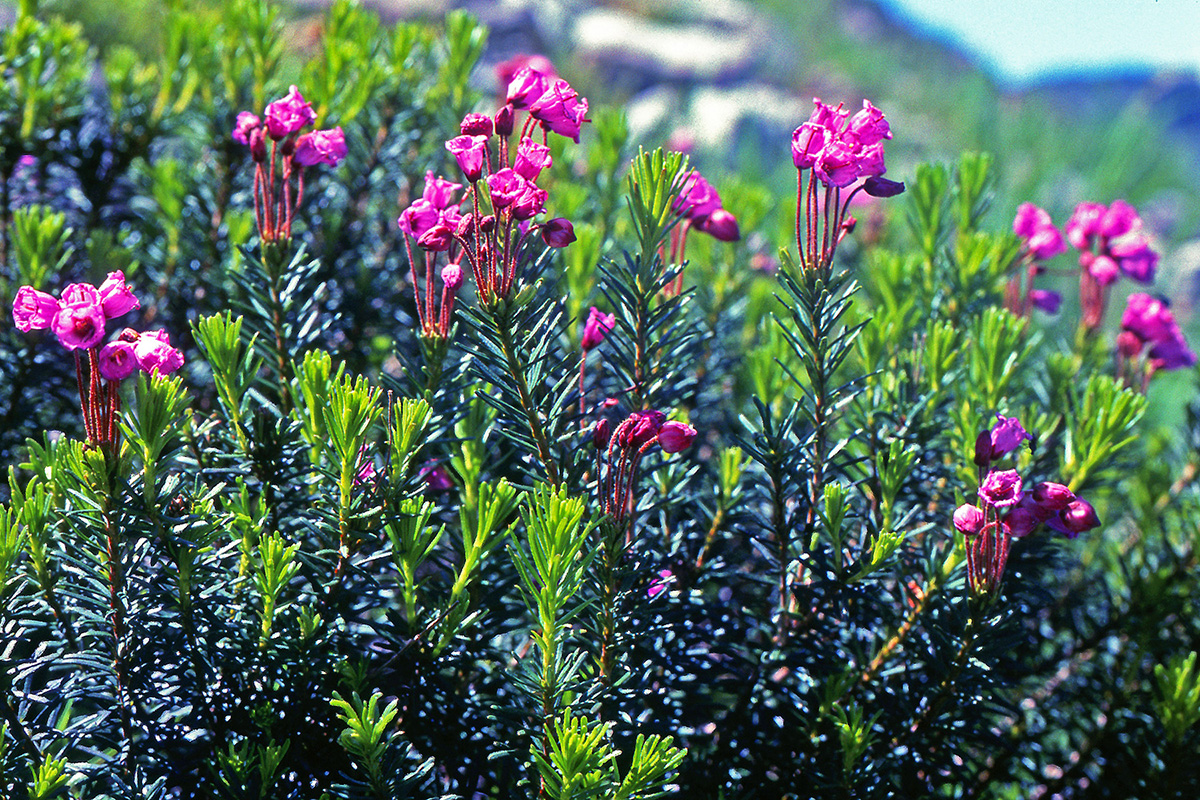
<box><xmin>881</xmin><ymin>0</ymin><xmax>1200</xmax><ymax>84</ymax></box>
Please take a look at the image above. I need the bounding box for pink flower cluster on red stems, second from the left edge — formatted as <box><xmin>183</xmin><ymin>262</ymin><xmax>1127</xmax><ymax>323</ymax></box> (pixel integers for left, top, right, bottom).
<box><xmin>233</xmin><ymin>86</ymin><xmax>346</xmax><ymax>242</ymax></box>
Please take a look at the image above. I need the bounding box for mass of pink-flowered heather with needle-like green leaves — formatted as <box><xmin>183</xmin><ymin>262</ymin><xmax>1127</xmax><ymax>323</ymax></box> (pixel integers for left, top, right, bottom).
<box><xmin>0</xmin><ymin>0</ymin><xmax>1200</xmax><ymax>800</ymax></box>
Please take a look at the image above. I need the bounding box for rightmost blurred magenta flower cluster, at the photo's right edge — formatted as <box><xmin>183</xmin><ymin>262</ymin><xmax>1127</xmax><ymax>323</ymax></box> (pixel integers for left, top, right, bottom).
<box><xmin>1117</xmin><ymin>291</ymin><xmax>1196</xmax><ymax>391</ymax></box>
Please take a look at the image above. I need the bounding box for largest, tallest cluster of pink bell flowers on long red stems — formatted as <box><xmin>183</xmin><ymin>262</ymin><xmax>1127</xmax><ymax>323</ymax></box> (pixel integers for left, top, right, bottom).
<box><xmin>424</xmin><ymin>58</ymin><xmax>588</xmax><ymax>303</ymax></box>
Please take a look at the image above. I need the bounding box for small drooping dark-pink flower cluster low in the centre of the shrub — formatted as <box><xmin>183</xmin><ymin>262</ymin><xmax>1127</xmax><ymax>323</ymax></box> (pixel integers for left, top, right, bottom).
<box><xmin>592</xmin><ymin>410</ymin><xmax>696</xmax><ymax>536</ymax></box>
